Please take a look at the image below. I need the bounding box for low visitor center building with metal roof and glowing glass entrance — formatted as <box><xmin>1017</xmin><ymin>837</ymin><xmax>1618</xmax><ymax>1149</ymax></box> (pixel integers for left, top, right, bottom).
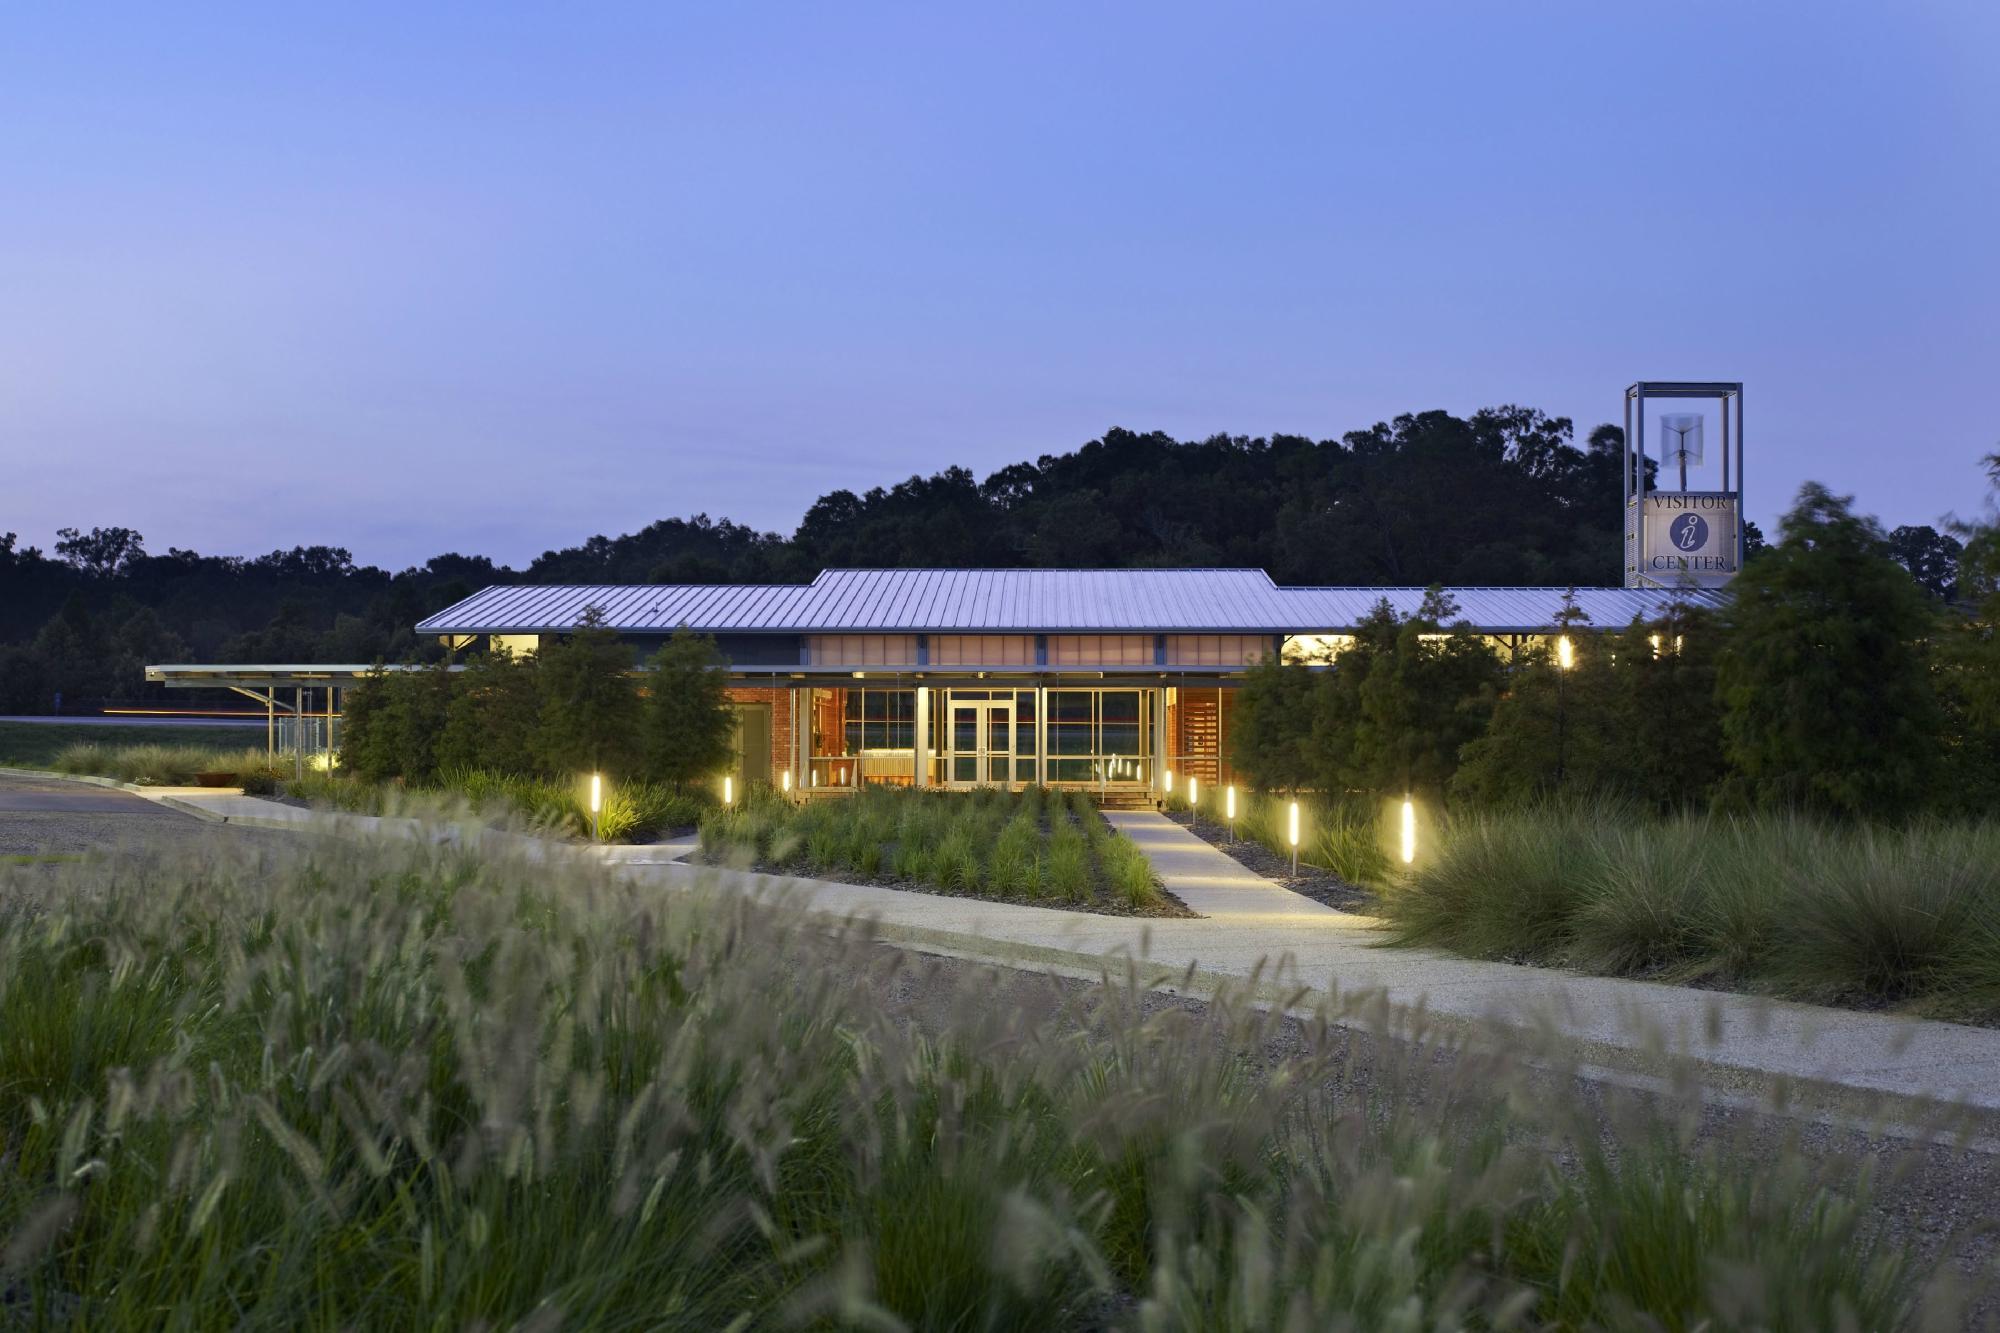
<box><xmin>402</xmin><ymin>568</ymin><xmax>1720</xmax><ymax>799</ymax></box>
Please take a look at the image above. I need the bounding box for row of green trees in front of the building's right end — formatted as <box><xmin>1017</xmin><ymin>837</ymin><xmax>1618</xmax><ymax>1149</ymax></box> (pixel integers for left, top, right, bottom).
<box><xmin>1230</xmin><ymin>472</ymin><xmax>2000</xmax><ymax>819</ymax></box>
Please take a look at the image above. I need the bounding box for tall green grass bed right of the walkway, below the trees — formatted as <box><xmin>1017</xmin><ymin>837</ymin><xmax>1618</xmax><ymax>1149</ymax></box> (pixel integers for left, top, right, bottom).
<box><xmin>1380</xmin><ymin>805</ymin><xmax>2000</xmax><ymax>1023</ymax></box>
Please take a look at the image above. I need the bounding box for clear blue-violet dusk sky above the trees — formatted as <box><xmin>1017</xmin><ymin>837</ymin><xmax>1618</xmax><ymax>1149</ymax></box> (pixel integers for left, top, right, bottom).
<box><xmin>0</xmin><ymin>0</ymin><xmax>2000</xmax><ymax>566</ymax></box>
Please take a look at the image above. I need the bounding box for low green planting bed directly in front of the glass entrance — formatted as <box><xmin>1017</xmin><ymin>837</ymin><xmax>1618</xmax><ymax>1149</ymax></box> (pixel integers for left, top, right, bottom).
<box><xmin>702</xmin><ymin>787</ymin><xmax>1172</xmax><ymax>913</ymax></box>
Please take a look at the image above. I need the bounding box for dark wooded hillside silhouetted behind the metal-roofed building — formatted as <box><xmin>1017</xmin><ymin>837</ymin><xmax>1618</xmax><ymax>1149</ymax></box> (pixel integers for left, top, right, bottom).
<box><xmin>0</xmin><ymin>406</ymin><xmax>1958</xmax><ymax>713</ymax></box>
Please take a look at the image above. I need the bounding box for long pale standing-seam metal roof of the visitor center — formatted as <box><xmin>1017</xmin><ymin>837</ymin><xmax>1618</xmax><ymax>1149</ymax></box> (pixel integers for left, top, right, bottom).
<box><xmin>416</xmin><ymin>568</ymin><xmax>1726</xmax><ymax>634</ymax></box>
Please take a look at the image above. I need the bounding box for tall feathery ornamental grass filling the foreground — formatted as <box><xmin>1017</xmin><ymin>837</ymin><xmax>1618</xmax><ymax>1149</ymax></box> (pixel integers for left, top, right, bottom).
<box><xmin>0</xmin><ymin>839</ymin><xmax>1960</xmax><ymax>1329</ymax></box>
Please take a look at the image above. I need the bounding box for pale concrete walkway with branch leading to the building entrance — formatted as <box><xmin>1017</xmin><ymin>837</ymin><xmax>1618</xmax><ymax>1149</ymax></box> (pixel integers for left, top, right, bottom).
<box><xmin>54</xmin><ymin>791</ymin><xmax>2000</xmax><ymax>1111</ymax></box>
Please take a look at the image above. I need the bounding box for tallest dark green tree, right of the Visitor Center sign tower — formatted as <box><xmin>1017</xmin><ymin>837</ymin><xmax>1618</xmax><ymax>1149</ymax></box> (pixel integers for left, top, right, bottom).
<box><xmin>1716</xmin><ymin>482</ymin><xmax>1940</xmax><ymax>819</ymax></box>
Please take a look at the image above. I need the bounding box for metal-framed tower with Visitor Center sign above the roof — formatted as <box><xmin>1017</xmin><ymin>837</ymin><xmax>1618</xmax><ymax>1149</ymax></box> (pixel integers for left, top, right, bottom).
<box><xmin>1624</xmin><ymin>380</ymin><xmax>1744</xmax><ymax>588</ymax></box>
